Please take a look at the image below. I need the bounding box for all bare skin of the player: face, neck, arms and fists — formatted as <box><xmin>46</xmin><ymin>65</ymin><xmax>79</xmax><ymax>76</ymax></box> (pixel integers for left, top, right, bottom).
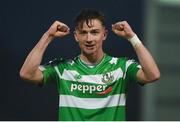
<box><xmin>20</xmin><ymin>19</ymin><xmax>160</xmax><ymax>84</ymax></box>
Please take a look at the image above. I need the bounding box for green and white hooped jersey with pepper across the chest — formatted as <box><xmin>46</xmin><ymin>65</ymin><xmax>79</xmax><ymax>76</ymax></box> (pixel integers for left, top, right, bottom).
<box><xmin>40</xmin><ymin>55</ymin><xmax>140</xmax><ymax>121</ymax></box>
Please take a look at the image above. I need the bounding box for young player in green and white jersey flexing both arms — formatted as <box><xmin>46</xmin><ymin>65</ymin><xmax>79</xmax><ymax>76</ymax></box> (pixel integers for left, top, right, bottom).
<box><xmin>20</xmin><ymin>9</ymin><xmax>160</xmax><ymax>121</ymax></box>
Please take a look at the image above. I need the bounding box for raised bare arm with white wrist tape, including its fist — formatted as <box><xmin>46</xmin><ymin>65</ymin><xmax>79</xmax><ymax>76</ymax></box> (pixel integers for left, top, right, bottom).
<box><xmin>112</xmin><ymin>21</ymin><xmax>160</xmax><ymax>83</ymax></box>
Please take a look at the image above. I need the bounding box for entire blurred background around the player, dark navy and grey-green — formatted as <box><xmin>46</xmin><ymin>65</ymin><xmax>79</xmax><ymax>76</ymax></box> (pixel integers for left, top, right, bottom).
<box><xmin>0</xmin><ymin>0</ymin><xmax>180</xmax><ymax>121</ymax></box>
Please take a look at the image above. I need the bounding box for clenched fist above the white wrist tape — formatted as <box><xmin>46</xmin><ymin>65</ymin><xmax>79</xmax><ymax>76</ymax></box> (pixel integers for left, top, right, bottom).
<box><xmin>112</xmin><ymin>21</ymin><xmax>135</xmax><ymax>39</ymax></box>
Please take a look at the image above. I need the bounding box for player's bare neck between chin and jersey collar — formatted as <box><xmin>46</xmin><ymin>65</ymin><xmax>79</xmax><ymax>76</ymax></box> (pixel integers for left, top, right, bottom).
<box><xmin>80</xmin><ymin>52</ymin><xmax>104</xmax><ymax>64</ymax></box>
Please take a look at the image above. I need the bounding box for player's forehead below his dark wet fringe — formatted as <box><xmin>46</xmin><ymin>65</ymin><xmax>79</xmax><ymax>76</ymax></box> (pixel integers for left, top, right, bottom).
<box><xmin>78</xmin><ymin>19</ymin><xmax>104</xmax><ymax>30</ymax></box>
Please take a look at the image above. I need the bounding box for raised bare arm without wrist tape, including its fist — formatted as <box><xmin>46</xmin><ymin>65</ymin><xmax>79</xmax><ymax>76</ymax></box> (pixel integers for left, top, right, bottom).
<box><xmin>20</xmin><ymin>21</ymin><xmax>70</xmax><ymax>84</ymax></box>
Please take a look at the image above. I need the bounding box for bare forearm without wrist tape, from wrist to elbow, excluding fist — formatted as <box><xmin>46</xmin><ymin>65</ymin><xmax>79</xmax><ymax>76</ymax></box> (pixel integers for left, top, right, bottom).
<box><xmin>20</xmin><ymin>33</ymin><xmax>53</xmax><ymax>80</ymax></box>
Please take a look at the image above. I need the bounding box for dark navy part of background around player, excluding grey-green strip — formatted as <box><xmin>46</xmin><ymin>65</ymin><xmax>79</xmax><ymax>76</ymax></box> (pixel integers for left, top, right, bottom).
<box><xmin>0</xmin><ymin>0</ymin><xmax>143</xmax><ymax>120</ymax></box>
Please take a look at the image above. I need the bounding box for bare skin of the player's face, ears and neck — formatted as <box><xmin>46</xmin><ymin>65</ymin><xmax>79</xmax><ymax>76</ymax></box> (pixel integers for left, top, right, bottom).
<box><xmin>74</xmin><ymin>19</ymin><xmax>107</xmax><ymax>63</ymax></box>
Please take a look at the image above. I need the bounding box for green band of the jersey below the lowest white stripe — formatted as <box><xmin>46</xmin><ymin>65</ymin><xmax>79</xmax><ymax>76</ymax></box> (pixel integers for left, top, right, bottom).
<box><xmin>59</xmin><ymin>106</ymin><xmax>125</xmax><ymax>121</ymax></box>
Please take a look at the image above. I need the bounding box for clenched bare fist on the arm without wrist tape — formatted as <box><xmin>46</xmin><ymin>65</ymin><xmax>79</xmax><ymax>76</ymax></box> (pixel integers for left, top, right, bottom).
<box><xmin>47</xmin><ymin>21</ymin><xmax>70</xmax><ymax>37</ymax></box>
